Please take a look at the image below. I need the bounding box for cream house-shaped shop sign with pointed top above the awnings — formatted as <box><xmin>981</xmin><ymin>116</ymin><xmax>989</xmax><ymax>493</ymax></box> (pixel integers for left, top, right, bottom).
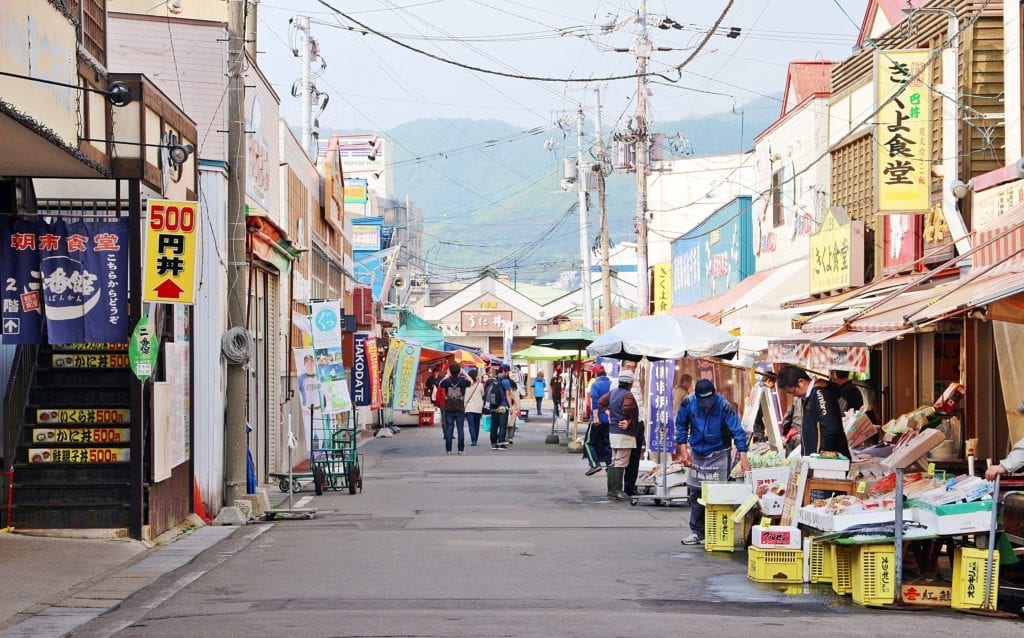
<box><xmin>809</xmin><ymin>206</ymin><xmax>864</xmax><ymax>293</ymax></box>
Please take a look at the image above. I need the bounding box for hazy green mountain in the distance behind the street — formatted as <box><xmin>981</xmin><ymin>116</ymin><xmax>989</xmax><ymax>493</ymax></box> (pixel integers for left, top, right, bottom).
<box><xmin>342</xmin><ymin>93</ymin><xmax>779</xmax><ymax>283</ymax></box>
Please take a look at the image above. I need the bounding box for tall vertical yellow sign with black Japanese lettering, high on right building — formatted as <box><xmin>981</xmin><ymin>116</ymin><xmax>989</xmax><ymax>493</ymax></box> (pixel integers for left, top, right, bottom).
<box><xmin>874</xmin><ymin>49</ymin><xmax>932</xmax><ymax>213</ymax></box>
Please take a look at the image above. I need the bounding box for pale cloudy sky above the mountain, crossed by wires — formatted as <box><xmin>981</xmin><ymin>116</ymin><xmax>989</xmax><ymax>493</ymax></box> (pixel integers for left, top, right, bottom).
<box><xmin>251</xmin><ymin>0</ymin><xmax>867</xmax><ymax>131</ymax></box>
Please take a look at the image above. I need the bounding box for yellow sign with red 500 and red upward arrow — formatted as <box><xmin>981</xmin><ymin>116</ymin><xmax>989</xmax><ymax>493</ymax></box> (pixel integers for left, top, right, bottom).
<box><xmin>142</xmin><ymin>200</ymin><xmax>200</xmax><ymax>304</ymax></box>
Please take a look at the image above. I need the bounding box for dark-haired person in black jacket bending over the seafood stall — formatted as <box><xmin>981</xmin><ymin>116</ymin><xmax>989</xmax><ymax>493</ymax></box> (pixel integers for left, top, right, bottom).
<box><xmin>777</xmin><ymin>366</ymin><xmax>851</xmax><ymax>459</ymax></box>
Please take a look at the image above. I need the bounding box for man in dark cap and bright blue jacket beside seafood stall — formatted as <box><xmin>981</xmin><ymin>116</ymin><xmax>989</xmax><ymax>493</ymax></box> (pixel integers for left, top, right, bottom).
<box><xmin>676</xmin><ymin>379</ymin><xmax>751</xmax><ymax>545</ymax></box>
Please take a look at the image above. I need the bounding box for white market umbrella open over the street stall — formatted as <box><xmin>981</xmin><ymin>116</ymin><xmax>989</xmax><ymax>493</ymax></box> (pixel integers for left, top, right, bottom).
<box><xmin>587</xmin><ymin>314</ymin><xmax>739</xmax><ymax>360</ymax></box>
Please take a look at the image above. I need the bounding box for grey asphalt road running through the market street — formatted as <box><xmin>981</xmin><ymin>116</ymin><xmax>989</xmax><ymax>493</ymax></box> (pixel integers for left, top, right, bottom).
<box><xmin>73</xmin><ymin>419</ymin><xmax>1024</xmax><ymax>638</ymax></box>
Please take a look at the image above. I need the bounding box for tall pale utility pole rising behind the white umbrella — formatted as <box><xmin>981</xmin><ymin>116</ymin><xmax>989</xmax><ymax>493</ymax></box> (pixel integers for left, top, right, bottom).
<box><xmin>635</xmin><ymin>2</ymin><xmax>650</xmax><ymax>316</ymax></box>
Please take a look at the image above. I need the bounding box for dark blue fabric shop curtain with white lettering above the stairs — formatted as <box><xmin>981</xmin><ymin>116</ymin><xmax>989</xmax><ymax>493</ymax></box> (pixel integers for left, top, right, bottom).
<box><xmin>0</xmin><ymin>218</ymin><xmax>129</xmax><ymax>344</ymax></box>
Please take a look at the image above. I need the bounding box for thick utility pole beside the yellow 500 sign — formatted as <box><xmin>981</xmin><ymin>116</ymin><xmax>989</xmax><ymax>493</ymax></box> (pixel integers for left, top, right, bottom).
<box><xmin>224</xmin><ymin>0</ymin><xmax>249</xmax><ymax>506</ymax></box>
